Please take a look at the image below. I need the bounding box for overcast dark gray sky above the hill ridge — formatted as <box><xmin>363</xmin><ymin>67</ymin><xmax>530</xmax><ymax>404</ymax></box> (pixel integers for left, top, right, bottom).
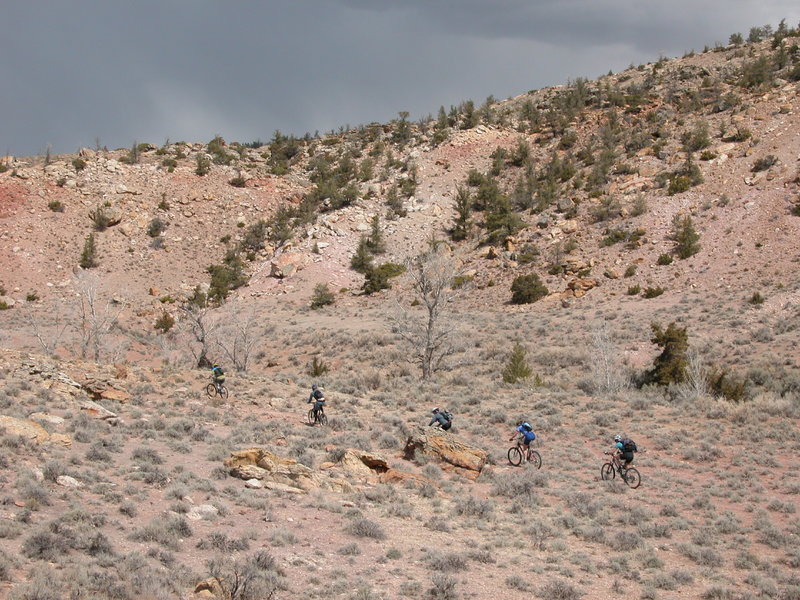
<box><xmin>0</xmin><ymin>0</ymin><xmax>800</xmax><ymax>156</ymax></box>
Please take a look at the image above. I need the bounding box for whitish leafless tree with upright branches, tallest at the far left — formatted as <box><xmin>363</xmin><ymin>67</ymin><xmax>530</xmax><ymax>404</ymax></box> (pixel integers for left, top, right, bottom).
<box><xmin>75</xmin><ymin>272</ymin><xmax>122</xmax><ymax>360</ymax></box>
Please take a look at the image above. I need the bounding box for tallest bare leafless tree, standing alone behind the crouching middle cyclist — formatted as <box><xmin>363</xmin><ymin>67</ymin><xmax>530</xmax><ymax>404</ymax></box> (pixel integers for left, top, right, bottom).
<box><xmin>393</xmin><ymin>243</ymin><xmax>460</xmax><ymax>379</ymax></box>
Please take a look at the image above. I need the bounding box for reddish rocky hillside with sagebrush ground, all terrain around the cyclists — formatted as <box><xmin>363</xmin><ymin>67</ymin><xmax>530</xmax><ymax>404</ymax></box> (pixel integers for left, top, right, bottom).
<box><xmin>0</xmin><ymin>28</ymin><xmax>800</xmax><ymax>600</ymax></box>
